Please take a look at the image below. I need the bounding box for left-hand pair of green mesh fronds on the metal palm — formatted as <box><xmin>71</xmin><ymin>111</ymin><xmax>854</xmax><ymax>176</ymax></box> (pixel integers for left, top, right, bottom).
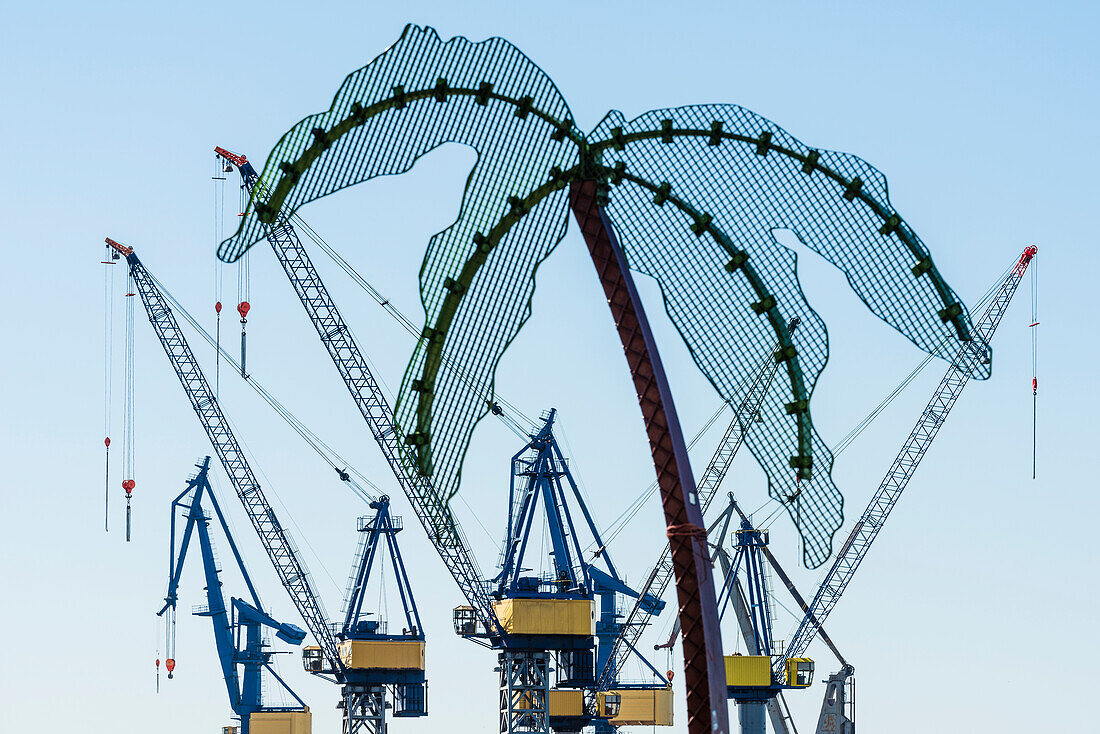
<box><xmin>210</xmin><ymin>25</ymin><xmax>579</xmax><ymax>497</ymax></box>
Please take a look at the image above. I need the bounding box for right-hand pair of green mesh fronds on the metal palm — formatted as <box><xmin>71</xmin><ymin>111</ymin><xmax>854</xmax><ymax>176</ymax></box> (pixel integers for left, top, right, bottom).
<box><xmin>589</xmin><ymin>105</ymin><xmax>965</xmax><ymax>567</ymax></box>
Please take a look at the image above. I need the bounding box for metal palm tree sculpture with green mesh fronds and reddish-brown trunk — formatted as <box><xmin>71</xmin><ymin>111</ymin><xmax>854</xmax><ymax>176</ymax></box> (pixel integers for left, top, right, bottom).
<box><xmin>219</xmin><ymin>26</ymin><xmax>986</xmax><ymax>731</ymax></box>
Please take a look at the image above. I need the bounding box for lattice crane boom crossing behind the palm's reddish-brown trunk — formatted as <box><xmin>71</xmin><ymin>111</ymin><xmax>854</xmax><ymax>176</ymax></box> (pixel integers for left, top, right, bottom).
<box><xmin>596</xmin><ymin>318</ymin><xmax>801</xmax><ymax>691</ymax></box>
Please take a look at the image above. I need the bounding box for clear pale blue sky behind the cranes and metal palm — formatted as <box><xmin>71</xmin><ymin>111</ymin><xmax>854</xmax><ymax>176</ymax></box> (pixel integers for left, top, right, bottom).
<box><xmin>0</xmin><ymin>2</ymin><xmax>1100</xmax><ymax>734</ymax></box>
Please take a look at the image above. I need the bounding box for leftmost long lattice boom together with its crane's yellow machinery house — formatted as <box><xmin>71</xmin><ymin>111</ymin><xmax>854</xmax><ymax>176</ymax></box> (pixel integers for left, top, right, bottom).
<box><xmin>107</xmin><ymin>238</ymin><xmax>427</xmax><ymax>734</ymax></box>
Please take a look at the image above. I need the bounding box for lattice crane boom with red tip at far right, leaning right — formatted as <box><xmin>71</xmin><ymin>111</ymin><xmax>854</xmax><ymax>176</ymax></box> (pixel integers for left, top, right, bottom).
<box><xmin>776</xmin><ymin>247</ymin><xmax>1037</xmax><ymax>670</ymax></box>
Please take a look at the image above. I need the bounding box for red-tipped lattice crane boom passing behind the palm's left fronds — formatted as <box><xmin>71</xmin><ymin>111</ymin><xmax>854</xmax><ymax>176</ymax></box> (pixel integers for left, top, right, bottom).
<box><xmin>215</xmin><ymin>147</ymin><xmax>497</xmax><ymax>631</ymax></box>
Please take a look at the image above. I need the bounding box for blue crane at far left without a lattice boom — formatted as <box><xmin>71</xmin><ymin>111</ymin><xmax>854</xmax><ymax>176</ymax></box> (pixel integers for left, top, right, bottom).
<box><xmin>157</xmin><ymin>457</ymin><xmax>311</xmax><ymax>734</ymax></box>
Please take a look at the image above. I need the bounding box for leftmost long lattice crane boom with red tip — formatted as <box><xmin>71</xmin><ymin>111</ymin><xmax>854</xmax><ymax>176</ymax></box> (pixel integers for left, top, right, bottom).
<box><xmin>107</xmin><ymin>238</ymin><xmax>343</xmax><ymax>671</ymax></box>
